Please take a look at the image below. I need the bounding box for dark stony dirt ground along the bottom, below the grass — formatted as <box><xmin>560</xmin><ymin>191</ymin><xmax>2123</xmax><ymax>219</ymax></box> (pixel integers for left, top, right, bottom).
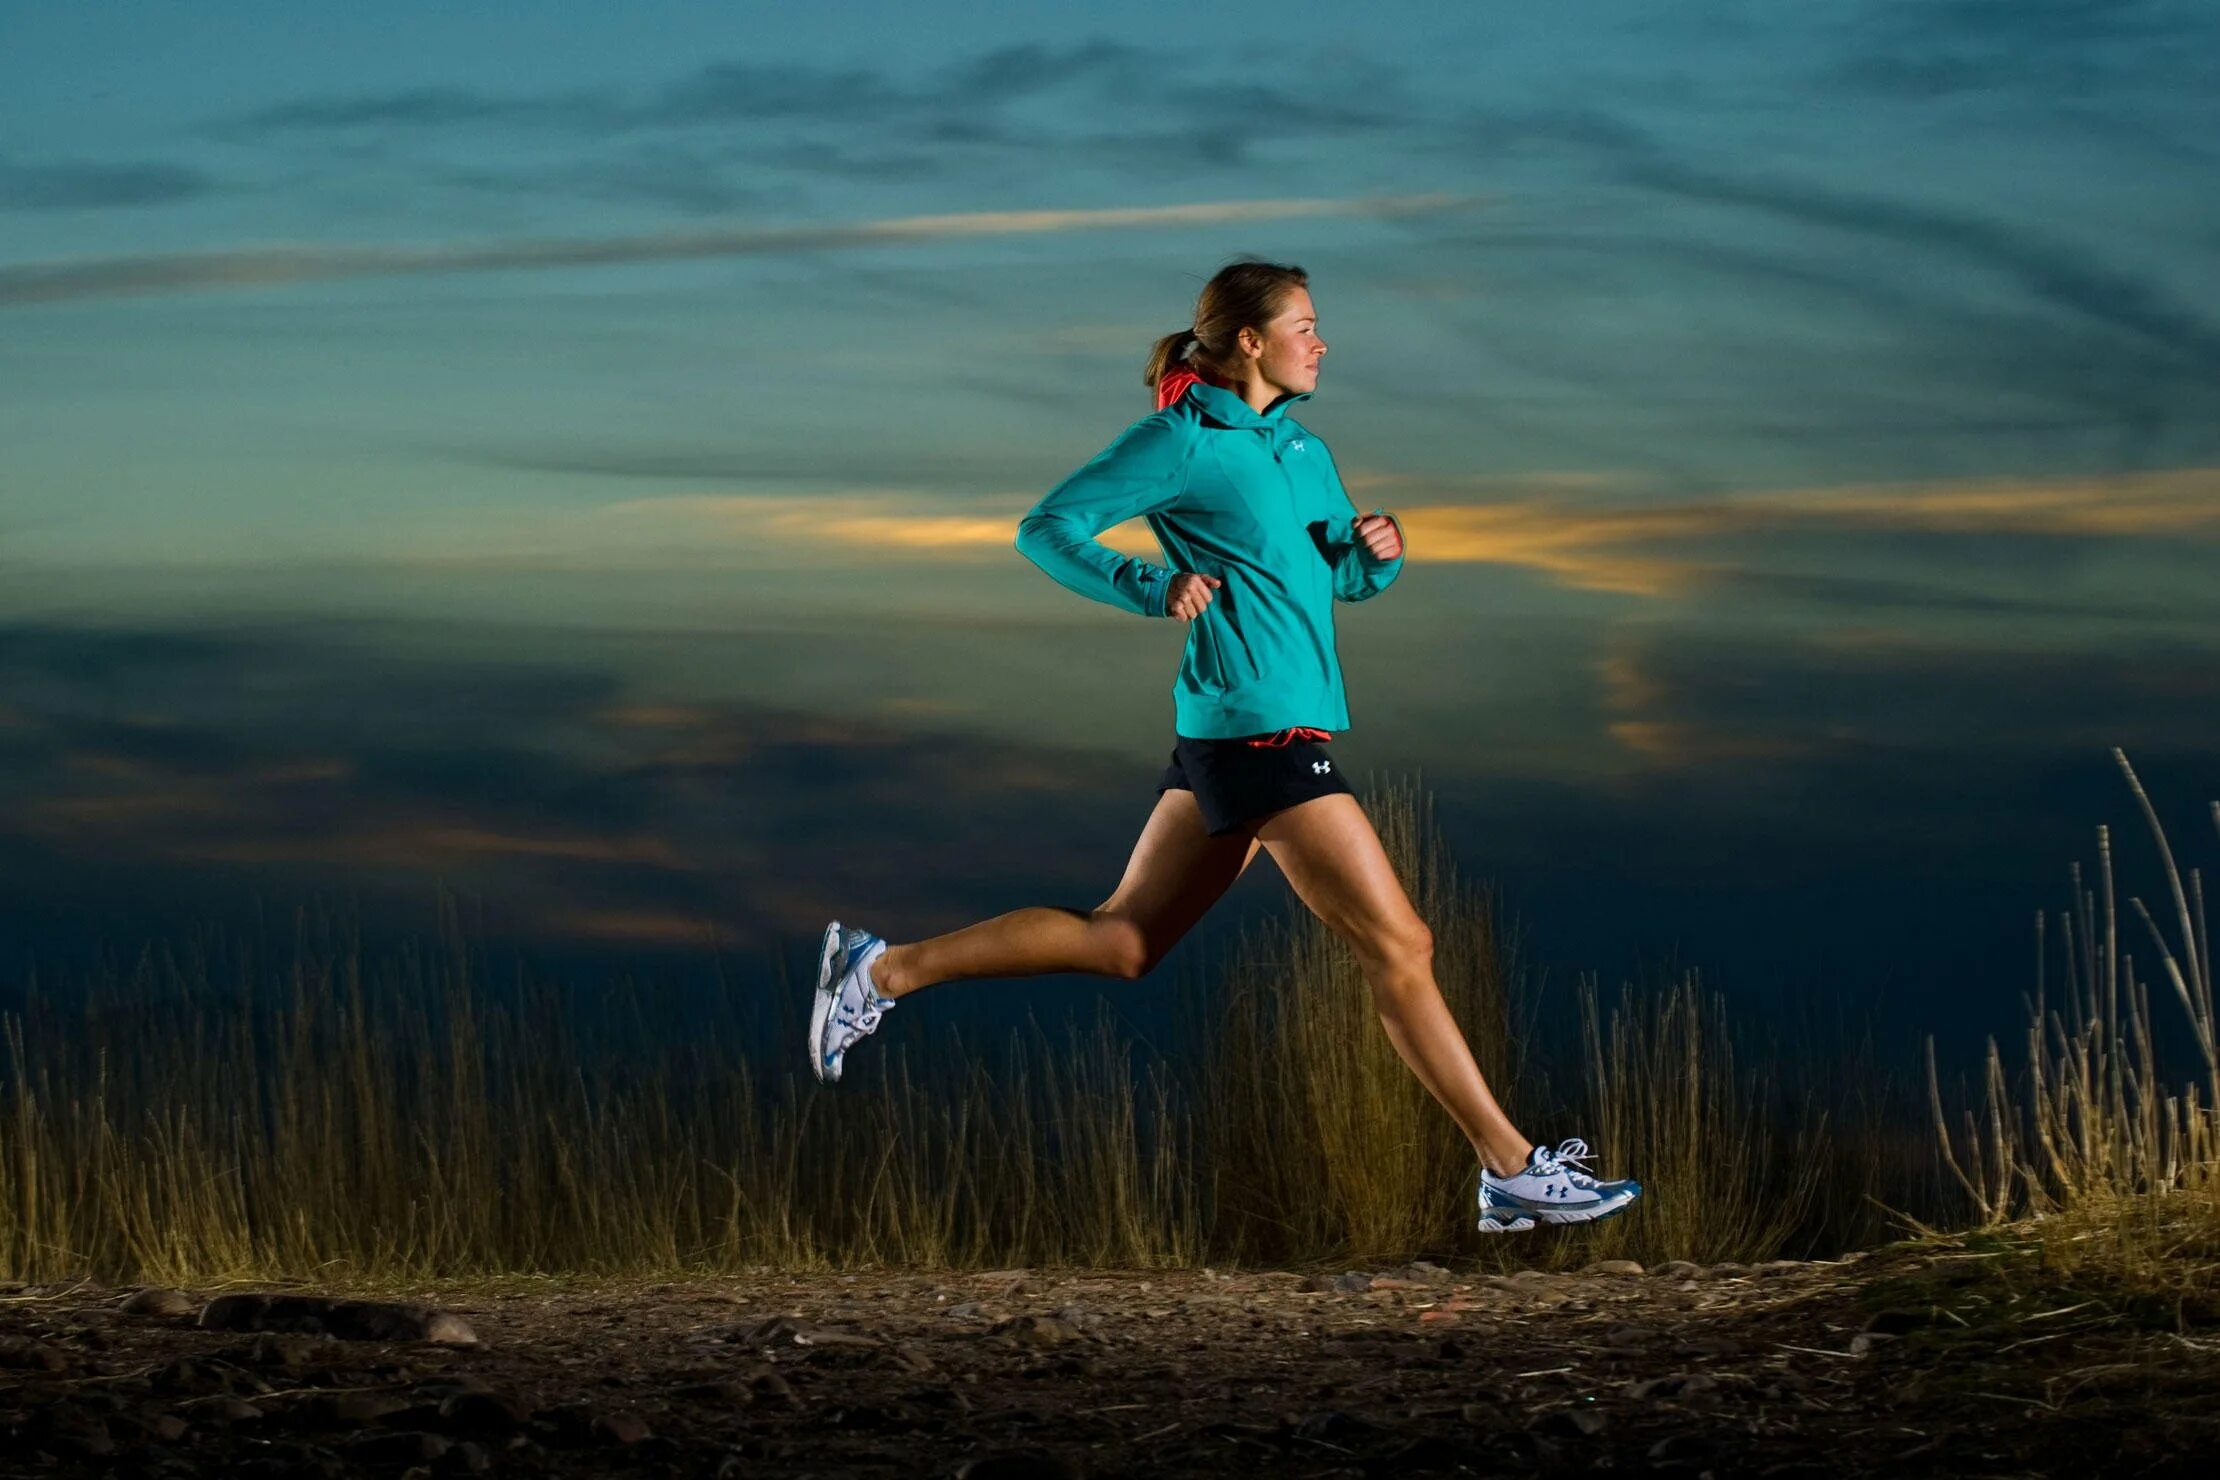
<box><xmin>0</xmin><ymin>1247</ymin><xmax>2220</xmax><ymax>1480</ymax></box>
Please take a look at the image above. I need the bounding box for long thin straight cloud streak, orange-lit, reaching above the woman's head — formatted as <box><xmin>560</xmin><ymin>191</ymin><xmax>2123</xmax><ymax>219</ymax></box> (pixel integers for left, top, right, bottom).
<box><xmin>0</xmin><ymin>193</ymin><xmax>1481</xmax><ymax>308</ymax></box>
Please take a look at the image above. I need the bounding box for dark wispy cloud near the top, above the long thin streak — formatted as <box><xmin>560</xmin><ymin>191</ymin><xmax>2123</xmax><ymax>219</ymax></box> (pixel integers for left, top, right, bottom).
<box><xmin>200</xmin><ymin>38</ymin><xmax>1425</xmax><ymax>194</ymax></box>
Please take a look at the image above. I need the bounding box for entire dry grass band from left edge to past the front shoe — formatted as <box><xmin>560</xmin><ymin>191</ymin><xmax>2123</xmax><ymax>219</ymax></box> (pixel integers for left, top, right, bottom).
<box><xmin>0</xmin><ymin>763</ymin><xmax>1871</xmax><ymax>1285</ymax></box>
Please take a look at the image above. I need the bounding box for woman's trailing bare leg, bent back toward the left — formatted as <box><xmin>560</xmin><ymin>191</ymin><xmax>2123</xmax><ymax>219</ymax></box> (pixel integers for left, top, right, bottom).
<box><xmin>872</xmin><ymin>785</ymin><xmax>1257</xmax><ymax>999</ymax></box>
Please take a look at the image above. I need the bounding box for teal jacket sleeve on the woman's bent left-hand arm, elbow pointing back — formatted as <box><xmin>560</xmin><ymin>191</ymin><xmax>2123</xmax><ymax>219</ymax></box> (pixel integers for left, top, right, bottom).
<box><xmin>1017</xmin><ymin>415</ymin><xmax>1190</xmax><ymax>617</ymax></box>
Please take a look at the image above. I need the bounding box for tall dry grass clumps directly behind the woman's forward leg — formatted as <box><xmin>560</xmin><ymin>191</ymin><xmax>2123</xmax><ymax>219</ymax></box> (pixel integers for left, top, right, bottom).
<box><xmin>1210</xmin><ymin>785</ymin><xmax>1847</xmax><ymax>1265</ymax></box>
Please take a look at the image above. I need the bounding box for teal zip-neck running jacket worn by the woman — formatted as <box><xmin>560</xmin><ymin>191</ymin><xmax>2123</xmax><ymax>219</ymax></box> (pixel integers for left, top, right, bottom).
<box><xmin>1017</xmin><ymin>384</ymin><xmax>1403</xmax><ymax>739</ymax></box>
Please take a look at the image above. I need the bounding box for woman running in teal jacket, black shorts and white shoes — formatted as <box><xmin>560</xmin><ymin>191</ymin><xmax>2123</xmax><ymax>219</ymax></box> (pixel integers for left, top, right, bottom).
<box><xmin>810</xmin><ymin>262</ymin><xmax>1641</xmax><ymax>1231</ymax></box>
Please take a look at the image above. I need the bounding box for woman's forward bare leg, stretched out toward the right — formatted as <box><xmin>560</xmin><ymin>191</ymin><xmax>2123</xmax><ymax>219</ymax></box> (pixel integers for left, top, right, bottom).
<box><xmin>1257</xmin><ymin>792</ymin><xmax>1534</xmax><ymax>1176</ymax></box>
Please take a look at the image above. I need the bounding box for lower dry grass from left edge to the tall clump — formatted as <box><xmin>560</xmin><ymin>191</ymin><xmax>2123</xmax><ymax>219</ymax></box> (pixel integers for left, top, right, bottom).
<box><xmin>0</xmin><ymin>949</ymin><xmax>1199</xmax><ymax>1280</ymax></box>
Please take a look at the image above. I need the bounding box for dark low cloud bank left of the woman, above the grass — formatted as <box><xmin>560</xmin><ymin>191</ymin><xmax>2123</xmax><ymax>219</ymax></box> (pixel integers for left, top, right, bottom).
<box><xmin>0</xmin><ymin>624</ymin><xmax>1154</xmax><ymax>950</ymax></box>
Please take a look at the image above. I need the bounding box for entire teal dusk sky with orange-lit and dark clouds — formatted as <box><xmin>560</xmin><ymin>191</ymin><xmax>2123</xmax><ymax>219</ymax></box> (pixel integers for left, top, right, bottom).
<box><xmin>0</xmin><ymin>0</ymin><xmax>2220</xmax><ymax>1078</ymax></box>
